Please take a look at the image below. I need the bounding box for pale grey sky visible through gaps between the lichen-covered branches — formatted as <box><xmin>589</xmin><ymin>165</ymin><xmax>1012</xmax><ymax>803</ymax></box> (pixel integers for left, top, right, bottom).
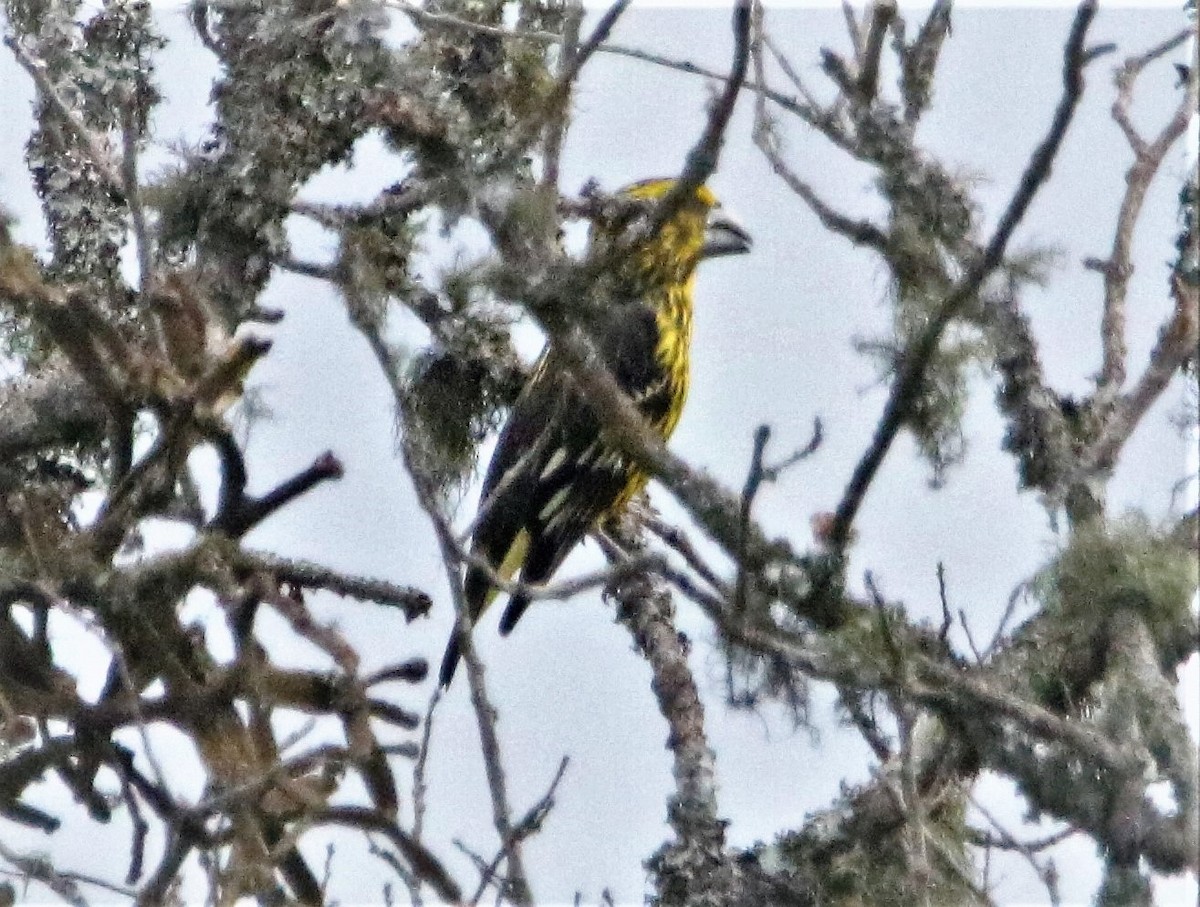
<box><xmin>0</xmin><ymin>7</ymin><xmax>1195</xmax><ymax>905</ymax></box>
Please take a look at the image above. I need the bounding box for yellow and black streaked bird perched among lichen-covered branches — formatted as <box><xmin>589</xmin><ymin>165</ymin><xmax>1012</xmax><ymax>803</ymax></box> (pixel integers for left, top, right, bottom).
<box><xmin>440</xmin><ymin>179</ymin><xmax>750</xmax><ymax>686</ymax></box>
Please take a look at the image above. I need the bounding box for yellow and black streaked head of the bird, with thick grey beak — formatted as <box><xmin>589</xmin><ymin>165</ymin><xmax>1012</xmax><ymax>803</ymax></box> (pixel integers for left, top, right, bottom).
<box><xmin>593</xmin><ymin>179</ymin><xmax>750</xmax><ymax>281</ymax></box>
